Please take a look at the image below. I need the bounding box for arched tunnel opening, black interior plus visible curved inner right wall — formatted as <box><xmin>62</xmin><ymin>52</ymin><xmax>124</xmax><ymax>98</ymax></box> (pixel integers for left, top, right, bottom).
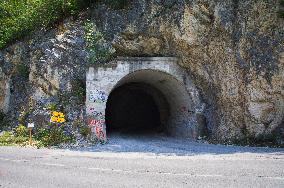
<box><xmin>105</xmin><ymin>70</ymin><xmax>194</xmax><ymax>137</ymax></box>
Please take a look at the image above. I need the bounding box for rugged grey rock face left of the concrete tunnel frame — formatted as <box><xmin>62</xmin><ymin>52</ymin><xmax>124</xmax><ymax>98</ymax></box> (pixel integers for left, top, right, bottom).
<box><xmin>0</xmin><ymin>16</ymin><xmax>87</xmax><ymax>131</ymax></box>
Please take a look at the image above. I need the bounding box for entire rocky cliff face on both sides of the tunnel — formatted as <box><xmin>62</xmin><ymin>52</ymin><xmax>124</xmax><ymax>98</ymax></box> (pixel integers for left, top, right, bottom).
<box><xmin>0</xmin><ymin>0</ymin><xmax>284</xmax><ymax>143</ymax></box>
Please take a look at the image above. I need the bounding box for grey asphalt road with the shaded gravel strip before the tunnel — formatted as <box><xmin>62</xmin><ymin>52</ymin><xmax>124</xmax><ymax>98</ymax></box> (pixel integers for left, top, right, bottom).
<box><xmin>0</xmin><ymin>136</ymin><xmax>284</xmax><ymax>188</ymax></box>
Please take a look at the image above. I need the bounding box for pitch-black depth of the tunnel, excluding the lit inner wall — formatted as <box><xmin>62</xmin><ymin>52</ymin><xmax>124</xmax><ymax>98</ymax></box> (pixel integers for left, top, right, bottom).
<box><xmin>106</xmin><ymin>83</ymin><xmax>165</xmax><ymax>134</ymax></box>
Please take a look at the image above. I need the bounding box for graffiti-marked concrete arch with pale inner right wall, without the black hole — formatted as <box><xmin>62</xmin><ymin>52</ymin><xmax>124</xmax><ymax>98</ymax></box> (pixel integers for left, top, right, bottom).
<box><xmin>86</xmin><ymin>57</ymin><xmax>202</xmax><ymax>139</ymax></box>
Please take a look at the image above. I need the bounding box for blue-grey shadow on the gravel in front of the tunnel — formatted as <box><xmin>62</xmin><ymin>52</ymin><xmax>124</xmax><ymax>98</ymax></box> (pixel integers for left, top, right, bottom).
<box><xmin>72</xmin><ymin>134</ymin><xmax>284</xmax><ymax>156</ymax></box>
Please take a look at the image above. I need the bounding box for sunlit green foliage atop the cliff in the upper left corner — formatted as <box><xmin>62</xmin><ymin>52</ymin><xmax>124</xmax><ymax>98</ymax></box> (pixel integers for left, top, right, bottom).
<box><xmin>0</xmin><ymin>0</ymin><xmax>91</xmax><ymax>49</ymax></box>
